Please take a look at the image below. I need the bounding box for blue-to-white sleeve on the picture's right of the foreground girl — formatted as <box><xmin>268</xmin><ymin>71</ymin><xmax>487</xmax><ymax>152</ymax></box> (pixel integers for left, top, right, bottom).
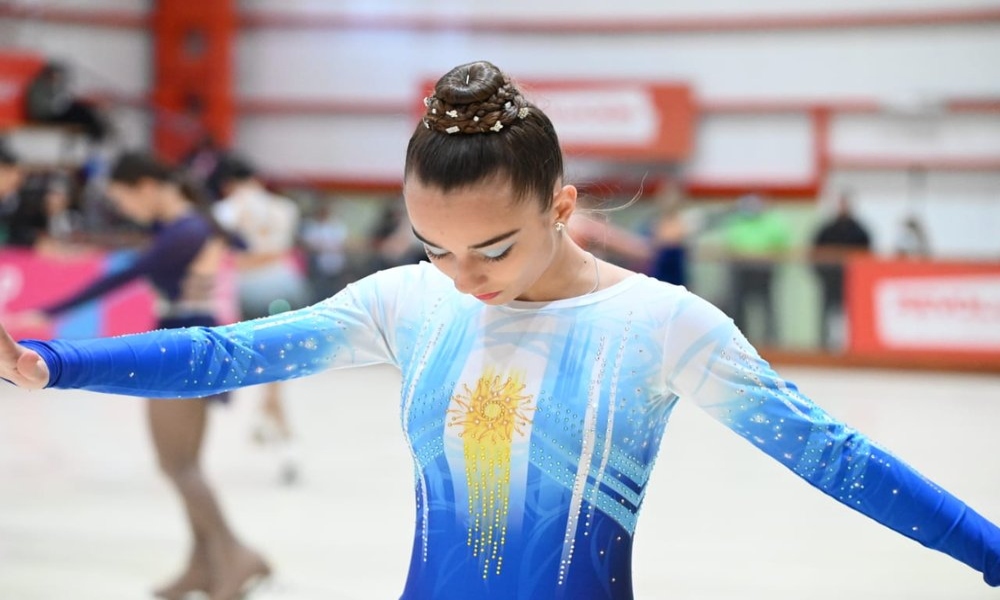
<box><xmin>664</xmin><ymin>296</ymin><xmax>1000</xmax><ymax>586</ymax></box>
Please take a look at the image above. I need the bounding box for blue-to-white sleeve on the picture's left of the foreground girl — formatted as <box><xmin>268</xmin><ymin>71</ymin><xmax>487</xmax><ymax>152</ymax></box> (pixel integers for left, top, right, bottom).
<box><xmin>21</xmin><ymin>281</ymin><xmax>395</xmax><ymax>398</ymax></box>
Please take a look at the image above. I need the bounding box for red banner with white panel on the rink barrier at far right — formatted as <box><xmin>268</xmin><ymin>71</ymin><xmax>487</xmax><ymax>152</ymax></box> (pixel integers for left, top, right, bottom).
<box><xmin>847</xmin><ymin>257</ymin><xmax>1000</xmax><ymax>368</ymax></box>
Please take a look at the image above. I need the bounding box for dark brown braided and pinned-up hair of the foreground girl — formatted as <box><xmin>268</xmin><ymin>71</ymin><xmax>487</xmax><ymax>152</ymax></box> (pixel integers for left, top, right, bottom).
<box><xmin>404</xmin><ymin>61</ymin><xmax>563</xmax><ymax>210</ymax></box>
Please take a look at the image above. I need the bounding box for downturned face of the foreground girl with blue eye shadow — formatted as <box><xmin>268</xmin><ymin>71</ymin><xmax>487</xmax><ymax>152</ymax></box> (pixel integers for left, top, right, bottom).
<box><xmin>403</xmin><ymin>177</ymin><xmax>576</xmax><ymax>304</ymax></box>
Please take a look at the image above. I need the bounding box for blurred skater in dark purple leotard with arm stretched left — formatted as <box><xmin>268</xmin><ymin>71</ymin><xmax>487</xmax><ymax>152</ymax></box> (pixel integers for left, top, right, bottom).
<box><xmin>14</xmin><ymin>153</ymin><xmax>270</xmax><ymax>600</ymax></box>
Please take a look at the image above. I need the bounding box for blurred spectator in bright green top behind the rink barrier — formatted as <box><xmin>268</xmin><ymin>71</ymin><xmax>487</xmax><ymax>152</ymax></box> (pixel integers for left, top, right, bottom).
<box><xmin>723</xmin><ymin>194</ymin><xmax>792</xmax><ymax>344</ymax></box>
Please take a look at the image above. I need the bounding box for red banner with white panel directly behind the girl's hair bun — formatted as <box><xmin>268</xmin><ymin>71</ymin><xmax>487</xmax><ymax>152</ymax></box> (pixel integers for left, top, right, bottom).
<box><xmin>416</xmin><ymin>79</ymin><xmax>695</xmax><ymax>162</ymax></box>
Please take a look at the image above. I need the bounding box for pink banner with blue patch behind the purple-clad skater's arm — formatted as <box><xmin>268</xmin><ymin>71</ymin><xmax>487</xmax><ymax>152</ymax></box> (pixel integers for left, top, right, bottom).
<box><xmin>0</xmin><ymin>249</ymin><xmax>155</xmax><ymax>339</ymax></box>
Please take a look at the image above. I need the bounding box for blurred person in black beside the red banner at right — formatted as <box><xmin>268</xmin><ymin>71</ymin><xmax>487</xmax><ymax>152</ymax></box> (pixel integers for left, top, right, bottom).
<box><xmin>812</xmin><ymin>191</ymin><xmax>871</xmax><ymax>350</ymax></box>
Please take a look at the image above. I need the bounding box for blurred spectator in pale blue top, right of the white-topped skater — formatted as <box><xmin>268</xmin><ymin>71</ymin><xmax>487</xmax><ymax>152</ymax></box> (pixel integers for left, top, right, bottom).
<box><xmin>302</xmin><ymin>203</ymin><xmax>348</xmax><ymax>302</ymax></box>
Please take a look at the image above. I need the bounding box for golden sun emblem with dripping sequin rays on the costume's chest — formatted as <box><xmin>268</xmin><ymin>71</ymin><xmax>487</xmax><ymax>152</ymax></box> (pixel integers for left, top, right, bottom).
<box><xmin>448</xmin><ymin>369</ymin><xmax>535</xmax><ymax>579</ymax></box>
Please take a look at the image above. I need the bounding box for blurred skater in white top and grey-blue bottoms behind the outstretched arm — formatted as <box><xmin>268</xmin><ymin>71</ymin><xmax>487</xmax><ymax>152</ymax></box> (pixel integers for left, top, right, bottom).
<box><xmin>213</xmin><ymin>155</ymin><xmax>309</xmax><ymax>483</ymax></box>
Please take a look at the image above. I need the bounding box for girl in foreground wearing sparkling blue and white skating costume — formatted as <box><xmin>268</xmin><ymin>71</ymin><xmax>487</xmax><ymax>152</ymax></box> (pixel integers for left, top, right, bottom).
<box><xmin>0</xmin><ymin>62</ymin><xmax>1000</xmax><ymax>600</ymax></box>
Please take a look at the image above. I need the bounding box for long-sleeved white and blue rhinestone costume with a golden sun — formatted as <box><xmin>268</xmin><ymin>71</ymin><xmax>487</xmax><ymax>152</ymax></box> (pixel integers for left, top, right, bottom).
<box><xmin>19</xmin><ymin>263</ymin><xmax>1000</xmax><ymax>600</ymax></box>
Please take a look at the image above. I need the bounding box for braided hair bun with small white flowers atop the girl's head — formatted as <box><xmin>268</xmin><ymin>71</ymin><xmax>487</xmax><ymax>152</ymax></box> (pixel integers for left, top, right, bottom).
<box><xmin>423</xmin><ymin>61</ymin><xmax>531</xmax><ymax>134</ymax></box>
